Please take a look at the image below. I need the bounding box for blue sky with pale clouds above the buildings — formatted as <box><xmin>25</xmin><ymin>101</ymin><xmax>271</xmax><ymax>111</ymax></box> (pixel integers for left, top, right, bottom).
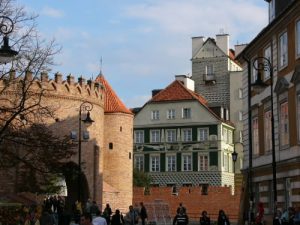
<box><xmin>16</xmin><ymin>0</ymin><xmax>268</xmax><ymax>108</ymax></box>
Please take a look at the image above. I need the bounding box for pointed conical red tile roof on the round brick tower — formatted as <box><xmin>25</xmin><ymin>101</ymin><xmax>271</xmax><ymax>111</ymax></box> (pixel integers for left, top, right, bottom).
<box><xmin>95</xmin><ymin>73</ymin><xmax>132</xmax><ymax>114</ymax></box>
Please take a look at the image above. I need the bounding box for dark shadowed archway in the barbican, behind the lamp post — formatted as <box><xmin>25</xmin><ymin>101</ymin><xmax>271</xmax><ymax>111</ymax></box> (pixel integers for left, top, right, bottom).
<box><xmin>62</xmin><ymin>162</ymin><xmax>90</xmax><ymax>211</ymax></box>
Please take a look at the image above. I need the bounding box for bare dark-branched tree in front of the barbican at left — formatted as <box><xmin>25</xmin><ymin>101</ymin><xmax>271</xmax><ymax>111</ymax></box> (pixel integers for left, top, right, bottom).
<box><xmin>0</xmin><ymin>0</ymin><xmax>74</xmax><ymax>192</ymax></box>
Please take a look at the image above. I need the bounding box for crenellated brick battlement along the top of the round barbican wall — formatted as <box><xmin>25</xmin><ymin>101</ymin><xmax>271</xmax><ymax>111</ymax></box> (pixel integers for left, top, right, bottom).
<box><xmin>0</xmin><ymin>70</ymin><xmax>105</xmax><ymax>103</ymax></box>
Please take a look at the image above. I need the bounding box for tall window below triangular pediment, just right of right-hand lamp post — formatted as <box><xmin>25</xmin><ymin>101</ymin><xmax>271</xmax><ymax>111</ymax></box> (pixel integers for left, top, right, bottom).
<box><xmin>280</xmin><ymin>102</ymin><xmax>289</xmax><ymax>147</ymax></box>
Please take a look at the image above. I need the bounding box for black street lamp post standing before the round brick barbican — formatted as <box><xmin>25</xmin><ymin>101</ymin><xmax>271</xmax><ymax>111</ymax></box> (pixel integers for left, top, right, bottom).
<box><xmin>78</xmin><ymin>101</ymin><xmax>94</xmax><ymax>202</ymax></box>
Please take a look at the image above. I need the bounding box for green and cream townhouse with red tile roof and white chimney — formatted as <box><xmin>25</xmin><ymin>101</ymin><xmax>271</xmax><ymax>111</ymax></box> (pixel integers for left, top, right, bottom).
<box><xmin>133</xmin><ymin>75</ymin><xmax>234</xmax><ymax>188</ymax></box>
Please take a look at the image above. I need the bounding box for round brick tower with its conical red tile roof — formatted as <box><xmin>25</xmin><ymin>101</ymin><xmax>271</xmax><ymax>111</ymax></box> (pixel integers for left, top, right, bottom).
<box><xmin>96</xmin><ymin>73</ymin><xmax>133</xmax><ymax>212</ymax></box>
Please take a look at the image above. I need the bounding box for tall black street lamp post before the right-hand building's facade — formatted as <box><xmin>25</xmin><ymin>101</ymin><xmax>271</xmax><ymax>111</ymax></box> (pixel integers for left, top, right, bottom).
<box><xmin>251</xmin><ymin>57</ymin><xmax>277</xmax><ymax>215</ymax></box>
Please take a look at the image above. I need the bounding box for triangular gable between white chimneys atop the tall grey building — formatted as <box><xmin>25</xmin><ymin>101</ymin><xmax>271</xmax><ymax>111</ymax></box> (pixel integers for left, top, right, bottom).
<box><xmin>193</xmin><ymin>38</ymin><xmax>226</xmax><ymax>59</ymax></box>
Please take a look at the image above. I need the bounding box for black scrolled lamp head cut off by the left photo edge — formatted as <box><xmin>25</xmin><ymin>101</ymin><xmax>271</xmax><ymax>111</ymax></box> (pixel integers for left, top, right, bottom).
<box><xmin>0</xmin><ymin>16</ymin><xmax>18</xmax><ymax>64</ymax></box>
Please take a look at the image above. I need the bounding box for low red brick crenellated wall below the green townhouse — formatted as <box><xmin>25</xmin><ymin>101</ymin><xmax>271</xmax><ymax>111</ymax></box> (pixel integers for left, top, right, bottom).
<box><xmin>133</xmin><ymin>186</ymin><xmax>241</xmax><ymax>222</ymax></box>
